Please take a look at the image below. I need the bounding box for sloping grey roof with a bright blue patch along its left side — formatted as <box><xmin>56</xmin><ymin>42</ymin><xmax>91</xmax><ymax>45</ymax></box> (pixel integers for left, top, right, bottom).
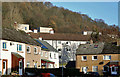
<box><xmin>36</xmin><ymin>39</ymin><xmax>57</xmax><ymax>52</ymax></box>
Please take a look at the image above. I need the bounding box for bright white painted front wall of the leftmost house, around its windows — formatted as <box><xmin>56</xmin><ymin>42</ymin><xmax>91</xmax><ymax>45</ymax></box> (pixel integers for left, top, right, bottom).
<box><xmin>0</xmin><ymin>40</ymin><xmax>25</xmax><ymax>74</ymax></box>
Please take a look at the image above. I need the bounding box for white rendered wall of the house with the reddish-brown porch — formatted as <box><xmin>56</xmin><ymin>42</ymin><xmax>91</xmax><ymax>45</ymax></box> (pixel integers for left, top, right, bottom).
<box><xmin>0</xmin><ymin>40</ymin><xmax>25</xmax><ymax>74</ymax></box>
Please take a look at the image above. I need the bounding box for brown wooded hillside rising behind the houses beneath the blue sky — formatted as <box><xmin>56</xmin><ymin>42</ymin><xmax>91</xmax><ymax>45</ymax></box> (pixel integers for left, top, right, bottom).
<box><xmin>2</xmin><ymin>2</ymin><xmax>119</xmax><ymax>33</ymax></box>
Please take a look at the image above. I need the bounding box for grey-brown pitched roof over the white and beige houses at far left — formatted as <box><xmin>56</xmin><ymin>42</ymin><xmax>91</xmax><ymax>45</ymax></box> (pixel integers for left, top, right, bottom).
<box><xmin>1</xmin><ymin>28</ymin><xmax>41</xmax><ymax>46</ymax></box>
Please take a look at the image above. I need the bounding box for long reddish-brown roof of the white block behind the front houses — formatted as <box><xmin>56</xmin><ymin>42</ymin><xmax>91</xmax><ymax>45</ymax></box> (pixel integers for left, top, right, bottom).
<box><xmin>30</xmin><ymin>33</ymin><xmax>90</xmax><ymax>41</ymax></box>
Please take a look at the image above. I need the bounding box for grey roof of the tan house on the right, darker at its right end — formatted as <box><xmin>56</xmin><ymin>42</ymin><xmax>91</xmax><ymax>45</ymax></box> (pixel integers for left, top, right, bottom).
<box><xmin>76</xmin><ymin>42</ymin><xmax>120</xmax><ymax>55</ymax></box>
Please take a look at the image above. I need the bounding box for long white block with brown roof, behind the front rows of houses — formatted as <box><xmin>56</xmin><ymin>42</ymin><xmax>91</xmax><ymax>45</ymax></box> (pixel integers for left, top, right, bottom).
<box><xmin>29</xmin><ymin>32</ymin><xmax>90</xmax><ymax>63</ymax></box>
